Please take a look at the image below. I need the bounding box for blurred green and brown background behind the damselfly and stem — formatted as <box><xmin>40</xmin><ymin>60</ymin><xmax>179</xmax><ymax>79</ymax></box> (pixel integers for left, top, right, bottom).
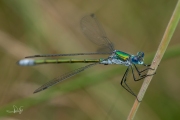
<box><xmin>0</xmin><ymin>0</ymin><xmax>180</xmax><ymax>120</ymax></box>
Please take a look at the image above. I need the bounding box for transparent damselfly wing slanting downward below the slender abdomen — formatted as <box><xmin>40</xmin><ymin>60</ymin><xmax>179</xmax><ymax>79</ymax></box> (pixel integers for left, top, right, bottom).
<box><xmin>34</xmin><ymin>63</ymin><xmax>99</xmax><ymax>93</ymax></box>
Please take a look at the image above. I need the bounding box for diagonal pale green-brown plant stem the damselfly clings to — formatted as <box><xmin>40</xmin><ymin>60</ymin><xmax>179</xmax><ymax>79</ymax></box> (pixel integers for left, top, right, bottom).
<box><xmin>127</xmin><ymin>0</ymin><xmax>180</xmax><ymax>120</ymax></box>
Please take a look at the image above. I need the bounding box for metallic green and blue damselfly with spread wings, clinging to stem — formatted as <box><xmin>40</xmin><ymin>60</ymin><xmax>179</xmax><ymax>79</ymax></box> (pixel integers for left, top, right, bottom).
<box><xmin>18</xmin><ymin>14</ymin><xmax>154</xmax><ymax>97</ymax></box>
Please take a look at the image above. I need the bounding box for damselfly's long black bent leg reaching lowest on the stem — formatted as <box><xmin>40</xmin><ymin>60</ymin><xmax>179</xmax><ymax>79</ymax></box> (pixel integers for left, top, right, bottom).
<box><xmin>121</xmin><ymin>66</ymin><xmax>137</xmax><ymax>98</ymax></box>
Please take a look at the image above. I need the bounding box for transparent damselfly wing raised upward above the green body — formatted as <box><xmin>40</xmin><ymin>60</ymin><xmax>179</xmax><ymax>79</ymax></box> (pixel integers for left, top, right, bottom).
<box><xmin>80</xmin><ymin>14</ymin><xmax>114</xmax><ymax>52</ymax></box>
